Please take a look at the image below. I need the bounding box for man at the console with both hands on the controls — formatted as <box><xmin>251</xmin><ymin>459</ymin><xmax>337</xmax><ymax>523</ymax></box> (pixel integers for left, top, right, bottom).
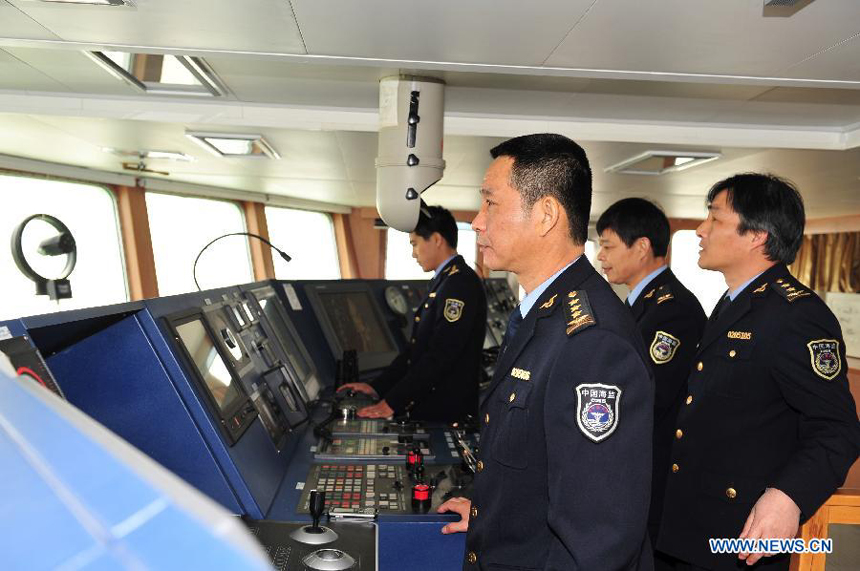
<box><xmin>339</xmin><ymin>206</ymin><xmax>487</xmax><ymax>421</ymax></box>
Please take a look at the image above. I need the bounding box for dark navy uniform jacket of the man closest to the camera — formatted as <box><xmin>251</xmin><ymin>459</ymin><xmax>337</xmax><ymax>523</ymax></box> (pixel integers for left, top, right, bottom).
<box><xmin>463</xmin><ymin>256</ymin><xmax>654</xmax><ymax>571</ymax></box>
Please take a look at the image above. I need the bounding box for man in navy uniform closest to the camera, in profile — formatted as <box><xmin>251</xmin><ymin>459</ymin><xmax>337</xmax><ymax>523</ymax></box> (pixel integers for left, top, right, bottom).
<box><xmin>439</xmin><ymin>134</ymin><xmax>654</xmax><ymax>571</ymax></box>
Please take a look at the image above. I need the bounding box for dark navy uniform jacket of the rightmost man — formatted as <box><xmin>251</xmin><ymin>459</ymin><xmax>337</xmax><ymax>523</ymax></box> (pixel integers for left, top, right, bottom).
<box><xmin>657</xmin><ymin>264</ymin><xmax>860</xmax><ymax>570</ymax></box>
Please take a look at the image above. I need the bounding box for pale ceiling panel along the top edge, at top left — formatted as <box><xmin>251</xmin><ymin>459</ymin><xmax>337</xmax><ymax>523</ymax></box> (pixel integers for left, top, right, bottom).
<box><xmin>10</xmin><ymin>0</ymin><xmax>305</xmax><ymax>53</ymax></box>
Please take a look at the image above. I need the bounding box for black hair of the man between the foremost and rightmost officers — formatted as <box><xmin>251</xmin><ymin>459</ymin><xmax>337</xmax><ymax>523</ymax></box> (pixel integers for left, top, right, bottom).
<box><xmin>597</xmin><ymin>198</ymin><xmax>669</xmax><ymax>258</ymax></box>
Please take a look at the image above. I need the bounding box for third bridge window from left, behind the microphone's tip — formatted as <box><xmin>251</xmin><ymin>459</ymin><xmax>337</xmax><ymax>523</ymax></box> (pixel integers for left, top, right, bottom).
<box><xmin>266</xmin><ymin>206</ymin><xmax>340</xmax><ymax>280</ymax></box>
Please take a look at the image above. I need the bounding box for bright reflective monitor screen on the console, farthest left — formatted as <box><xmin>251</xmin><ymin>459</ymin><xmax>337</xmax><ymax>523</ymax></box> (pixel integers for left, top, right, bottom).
<box><xmin>176</xmin><ymin>319</ymin><xmax>243</xmax><ymax>412</ymax></box>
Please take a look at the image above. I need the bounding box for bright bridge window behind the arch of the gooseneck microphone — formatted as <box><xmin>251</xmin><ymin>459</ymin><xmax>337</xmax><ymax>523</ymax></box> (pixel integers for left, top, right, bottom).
<box><xmin>146</xmin><ymin>192</ymin><xmax>254</xmax><ymax>296</ymax></box>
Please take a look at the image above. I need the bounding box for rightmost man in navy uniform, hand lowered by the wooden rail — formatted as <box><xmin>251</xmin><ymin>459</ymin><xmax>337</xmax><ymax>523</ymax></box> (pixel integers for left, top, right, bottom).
<box><xmin>657</xmin><ymin>174</ymin><xmax>860</xmax><ymax>571</ymax></box>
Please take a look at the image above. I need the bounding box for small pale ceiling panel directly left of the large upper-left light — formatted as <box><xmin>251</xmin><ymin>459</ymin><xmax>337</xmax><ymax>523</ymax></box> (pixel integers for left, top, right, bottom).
<box><xmin>6</xmin><ymin>48</ymin><xmax>140</xmax><ymax>95</ymax></box>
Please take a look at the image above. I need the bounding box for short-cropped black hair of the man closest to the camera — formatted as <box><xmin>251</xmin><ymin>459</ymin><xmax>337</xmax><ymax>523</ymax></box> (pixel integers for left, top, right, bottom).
<box><xmin>490</xmin><ymin>133</ymin><xmax>591</xmax><ymax>244</ymax></box>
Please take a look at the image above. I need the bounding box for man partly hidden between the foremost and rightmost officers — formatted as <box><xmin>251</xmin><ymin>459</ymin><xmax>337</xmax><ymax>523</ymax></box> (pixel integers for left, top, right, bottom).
<box><xmin>597</xmin><ymin>198</ymin><xmax>706</xmax><ymax>556</ymax></box>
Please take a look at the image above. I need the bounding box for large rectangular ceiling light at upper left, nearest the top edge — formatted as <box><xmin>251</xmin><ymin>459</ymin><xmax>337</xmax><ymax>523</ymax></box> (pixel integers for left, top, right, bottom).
<box><xmin>84</xmin><ymin>50</ymin><xmax>227</xmax><ymax>97</ymax></box>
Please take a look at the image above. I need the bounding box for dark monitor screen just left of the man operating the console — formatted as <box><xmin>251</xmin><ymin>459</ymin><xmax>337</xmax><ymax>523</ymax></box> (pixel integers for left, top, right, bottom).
<box><xmin>317</xmin><ymin>289</ymin><xmax>397</xmax><ymax>355</ymax></box>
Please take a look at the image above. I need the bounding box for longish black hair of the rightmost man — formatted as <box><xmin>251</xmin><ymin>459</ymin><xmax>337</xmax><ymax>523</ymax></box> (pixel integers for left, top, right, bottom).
<box><xmin>708</xmin><ymin>173</ymin><xmax>806</xmax><ymax>265</ymax></box>
